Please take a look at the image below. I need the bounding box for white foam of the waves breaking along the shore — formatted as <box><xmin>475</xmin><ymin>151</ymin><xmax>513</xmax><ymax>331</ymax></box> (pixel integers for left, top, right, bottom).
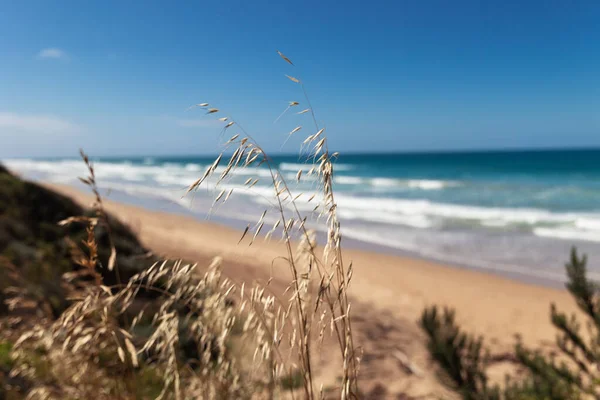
<box><xmin>3</xmin><ymin>159</ymin><xmax>600</xmax><ymax>242</ymax></box>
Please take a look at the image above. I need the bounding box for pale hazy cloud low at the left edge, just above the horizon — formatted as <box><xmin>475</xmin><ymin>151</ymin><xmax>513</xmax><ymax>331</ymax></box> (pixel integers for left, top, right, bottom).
<box><xmin>0</xmin><ymin>111</ymin><xmax>83</xmax><ymax>138</ymax></box>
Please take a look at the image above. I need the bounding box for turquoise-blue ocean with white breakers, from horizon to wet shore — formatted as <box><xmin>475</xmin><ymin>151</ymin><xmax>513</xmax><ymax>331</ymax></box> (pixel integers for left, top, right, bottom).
<box><xmin>7</xmin><ymin>150</ymin><xmax>600</xmax><ymax>284</ymax></box>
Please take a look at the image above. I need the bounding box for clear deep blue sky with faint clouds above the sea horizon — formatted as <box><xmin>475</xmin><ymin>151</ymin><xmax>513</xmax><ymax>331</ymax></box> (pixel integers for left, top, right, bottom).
<box><xmin>0</xmin><ymin>0</ymin><xmax>600</xmax><ymax>158</ymax></box>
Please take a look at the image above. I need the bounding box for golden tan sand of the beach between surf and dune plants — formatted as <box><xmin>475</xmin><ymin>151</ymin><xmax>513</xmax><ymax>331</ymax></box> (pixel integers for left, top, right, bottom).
<box><xmin>51</xmin><ymin>185</ymin><xmax>576</xmax><ymax>399</ymax></box>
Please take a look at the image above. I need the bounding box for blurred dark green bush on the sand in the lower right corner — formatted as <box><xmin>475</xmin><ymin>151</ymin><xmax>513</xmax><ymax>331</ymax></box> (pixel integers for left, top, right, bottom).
<box><xmin>421</xmin><ymin>249</ymin><xmax>600</xmax><ymax>400</ymax></box>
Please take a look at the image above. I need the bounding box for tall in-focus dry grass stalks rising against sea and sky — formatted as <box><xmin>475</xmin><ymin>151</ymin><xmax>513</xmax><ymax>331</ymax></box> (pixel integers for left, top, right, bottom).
<box><xmin>187</xmin><ymin>52</ymin><xmax>359</xmax><ymax>399</ymax></box>
